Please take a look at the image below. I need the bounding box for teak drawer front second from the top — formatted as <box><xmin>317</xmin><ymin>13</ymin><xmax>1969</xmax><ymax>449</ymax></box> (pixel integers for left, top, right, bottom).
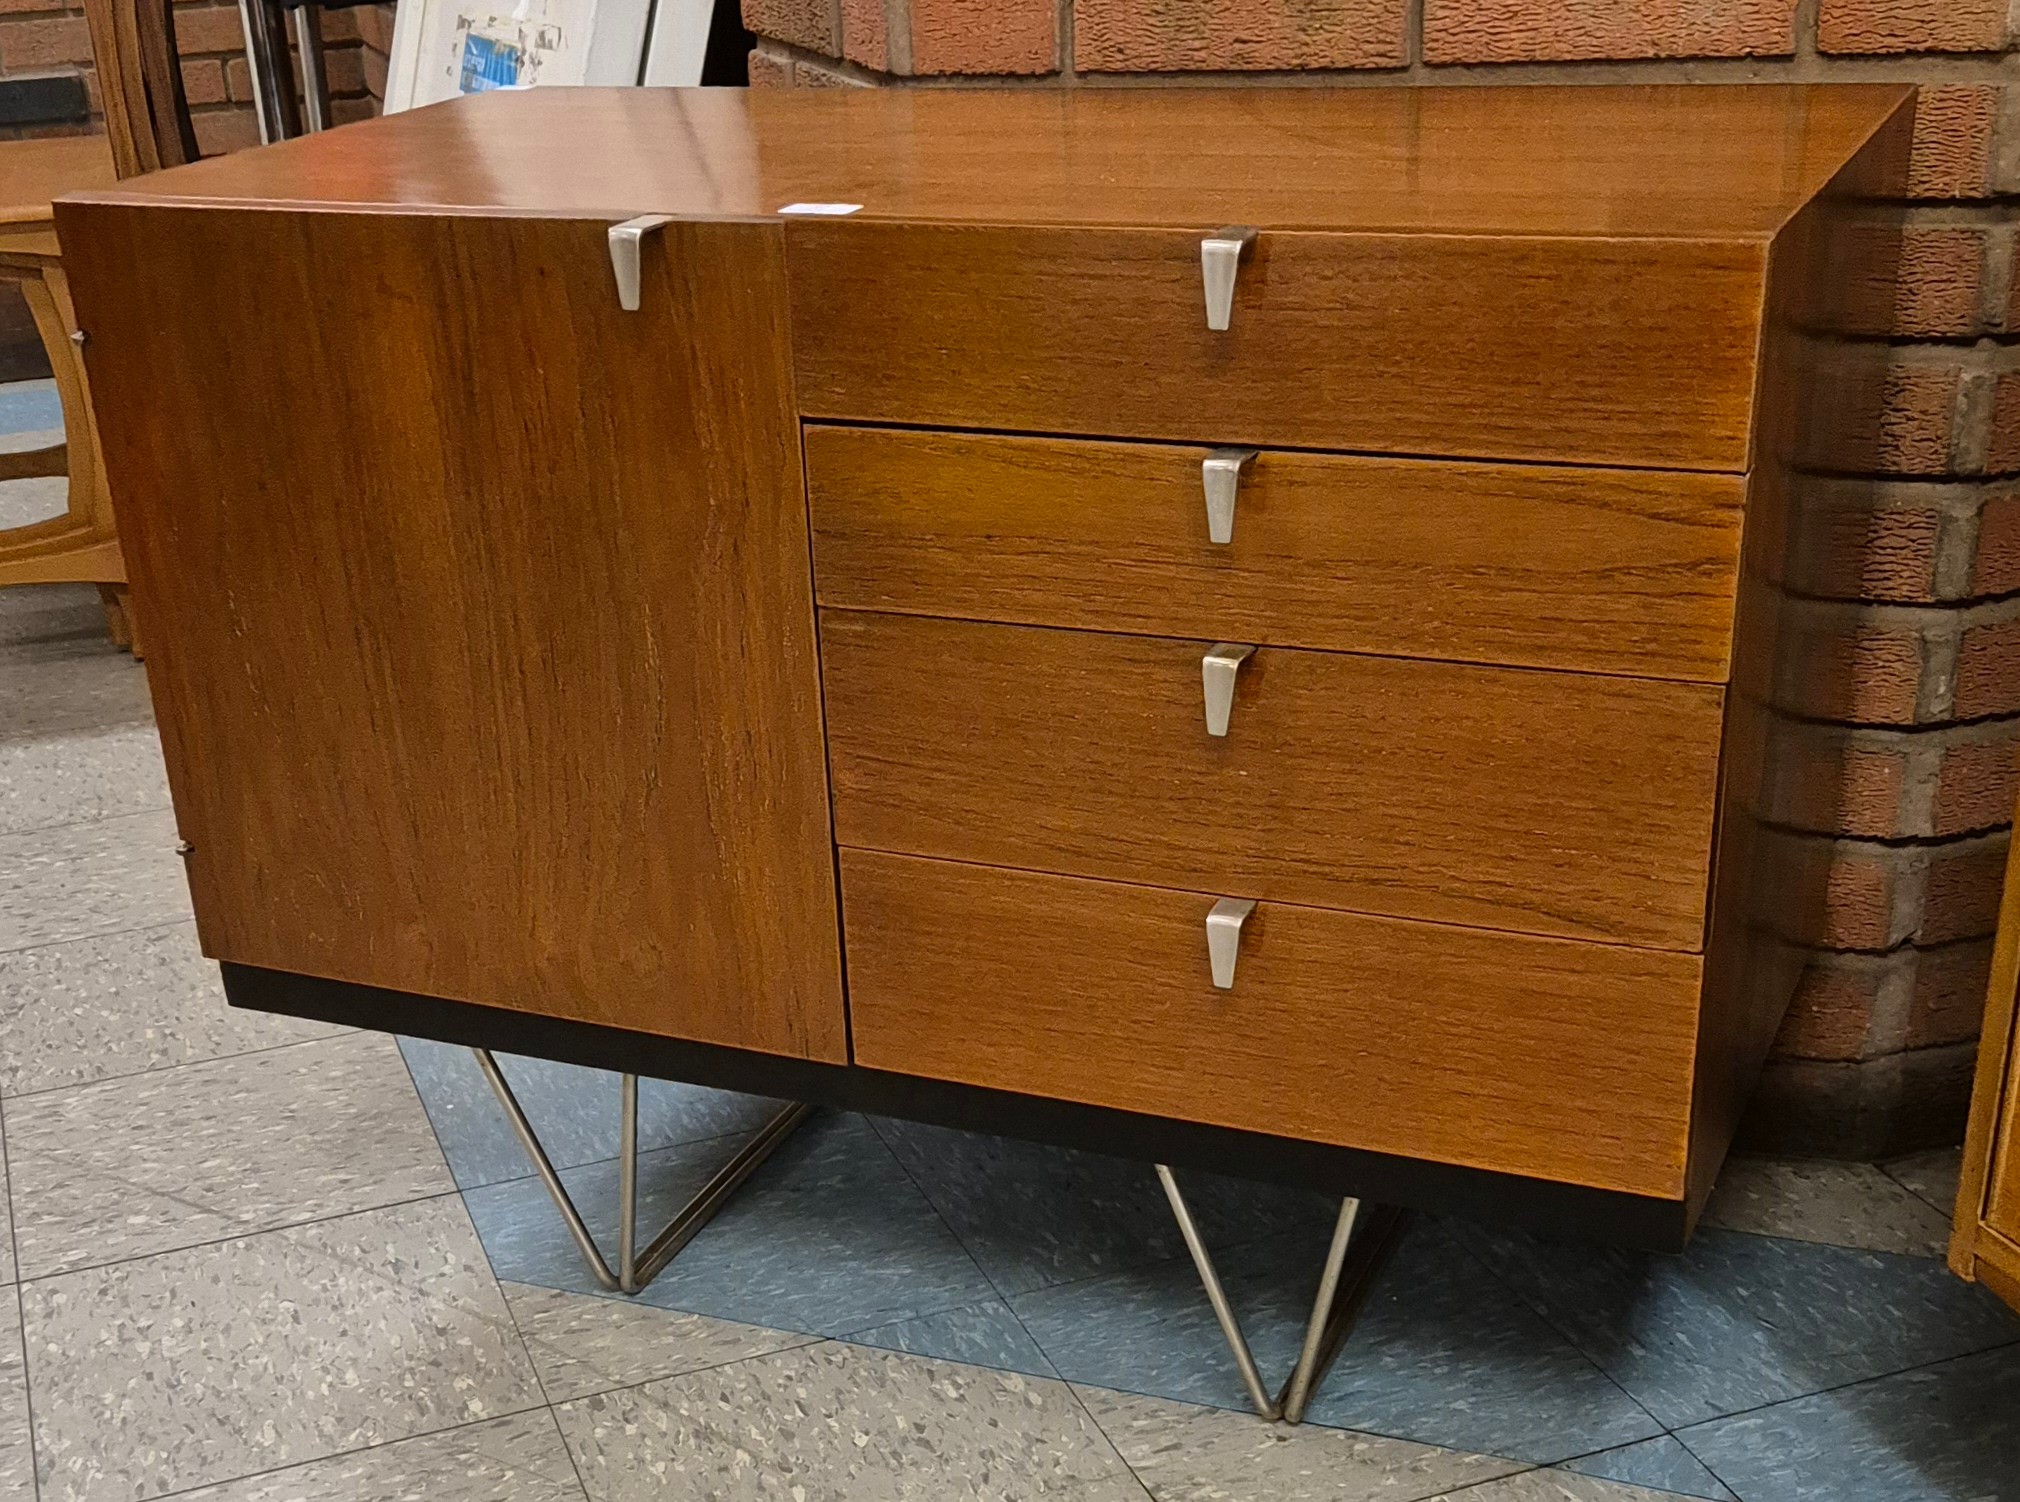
<box><xmin>806</xmin><ymin>426</ymin><xmax>1743</xmax><ymax>682</ymax></box>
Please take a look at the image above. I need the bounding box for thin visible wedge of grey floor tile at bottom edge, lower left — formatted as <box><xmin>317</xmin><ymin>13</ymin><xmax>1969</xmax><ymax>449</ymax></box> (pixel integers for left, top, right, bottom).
<box><xmin>176</xmin><ymin>1409</ymin><xmax>584</xmax><ymax>1502</ymax></box>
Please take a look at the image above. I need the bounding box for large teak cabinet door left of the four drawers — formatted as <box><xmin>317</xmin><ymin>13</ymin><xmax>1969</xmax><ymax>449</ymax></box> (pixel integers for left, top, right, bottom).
<box><xmin>61</xmin><ymin>206</ymin><xmax>846</xmax><ymax>1060</ymax></box>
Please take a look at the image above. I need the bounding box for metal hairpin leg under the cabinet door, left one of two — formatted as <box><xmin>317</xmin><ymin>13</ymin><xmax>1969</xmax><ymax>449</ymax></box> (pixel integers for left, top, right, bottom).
<box><xmin>471</xmin><ymin>1048</ymin><xmax>814</xmax><ymax>1294</ymax></box>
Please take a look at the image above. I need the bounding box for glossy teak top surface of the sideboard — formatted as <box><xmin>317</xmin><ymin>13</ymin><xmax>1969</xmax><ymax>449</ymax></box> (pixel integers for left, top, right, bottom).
<box><xmin>77</xmin><ymin>85</ymin><xmax>1913</xmax><ymax>238</ymax></box>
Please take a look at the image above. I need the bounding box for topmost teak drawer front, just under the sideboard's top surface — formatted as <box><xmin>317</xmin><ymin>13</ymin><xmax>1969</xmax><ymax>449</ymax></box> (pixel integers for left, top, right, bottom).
<box><xmin>786</xmin><ymin>220</ymin><xmax>1765</xmax><ymax>472</ymax></box>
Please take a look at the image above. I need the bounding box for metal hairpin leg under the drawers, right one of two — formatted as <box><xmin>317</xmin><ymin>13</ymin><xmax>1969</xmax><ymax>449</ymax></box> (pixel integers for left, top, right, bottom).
<box><xmin>1157</xmin><ymin>1163</ymin><xmax>1404</xmax><ymax>1423</ymax></box>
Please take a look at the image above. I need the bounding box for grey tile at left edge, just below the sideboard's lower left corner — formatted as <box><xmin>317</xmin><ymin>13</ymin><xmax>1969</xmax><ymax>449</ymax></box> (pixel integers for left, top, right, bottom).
<box><xmin>8</xmin><ymin>1034</ymin><xmax>455</xmax><ymax>1278</ymax></box>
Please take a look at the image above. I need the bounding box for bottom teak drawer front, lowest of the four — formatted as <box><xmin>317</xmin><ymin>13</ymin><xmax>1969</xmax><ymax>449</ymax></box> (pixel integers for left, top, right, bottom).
<box><xmin>842</xmin><ymin>850</ymin><xmax>1701</xmax><ymax>1197</ymax></box>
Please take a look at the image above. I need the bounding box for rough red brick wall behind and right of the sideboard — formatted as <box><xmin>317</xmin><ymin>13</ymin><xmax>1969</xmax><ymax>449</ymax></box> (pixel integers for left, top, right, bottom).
<box><xmin>743</xmin><ymin>0</ymin><xmax>2020</xmax><ymax>1155</ymax></box>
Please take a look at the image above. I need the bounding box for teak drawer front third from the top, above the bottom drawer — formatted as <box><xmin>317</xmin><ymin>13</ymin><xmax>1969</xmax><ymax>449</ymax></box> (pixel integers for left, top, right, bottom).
<box><xmin>820</xmin><ymin>610</ymin><xmax>1721</xmax><ymax>949</ymax></box>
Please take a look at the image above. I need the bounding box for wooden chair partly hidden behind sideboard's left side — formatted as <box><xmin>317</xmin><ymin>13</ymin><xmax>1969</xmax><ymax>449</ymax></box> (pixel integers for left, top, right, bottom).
<box><xmin>0</xmin><ymin>0</ymin><xmax>198</xmax><ymax>654</ymax></box>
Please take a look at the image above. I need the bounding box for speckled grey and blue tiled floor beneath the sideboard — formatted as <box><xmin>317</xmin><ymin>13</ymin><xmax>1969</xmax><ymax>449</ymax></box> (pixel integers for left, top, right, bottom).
<box><xmin>0</xmin><ymin>381</ymin><xmax>2020</xmax><ymax>1502</ymax></box>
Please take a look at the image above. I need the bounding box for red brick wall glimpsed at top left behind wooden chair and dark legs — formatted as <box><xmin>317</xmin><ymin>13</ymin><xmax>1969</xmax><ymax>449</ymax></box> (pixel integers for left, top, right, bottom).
<box><xmin>0</xmin><ymin>0</ymin><xmax>392</xmax><ymax>153</ymax></box>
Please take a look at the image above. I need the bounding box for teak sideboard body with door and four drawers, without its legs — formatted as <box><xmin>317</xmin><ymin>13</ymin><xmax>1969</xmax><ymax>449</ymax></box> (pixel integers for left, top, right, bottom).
<box><xmin>59</xmin><ymin>87</ymin><xmax>1913</xmax><ymax>1244</ymax></box>
